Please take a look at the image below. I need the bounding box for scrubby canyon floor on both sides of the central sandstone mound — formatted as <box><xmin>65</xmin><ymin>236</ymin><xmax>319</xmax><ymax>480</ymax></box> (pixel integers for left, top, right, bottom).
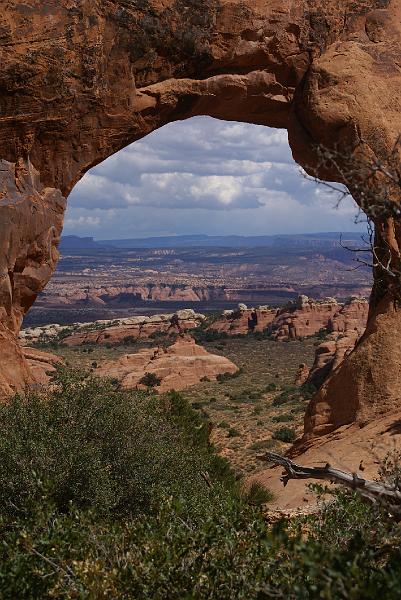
<box><xmin>32</xmin><ymin>335</ymin><xmax>320</xmax><ymax>476</ymax></box>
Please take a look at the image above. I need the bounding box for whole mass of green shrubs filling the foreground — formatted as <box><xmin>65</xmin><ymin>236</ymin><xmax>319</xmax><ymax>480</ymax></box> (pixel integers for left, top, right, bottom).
<box><xmin>0</xmin><ymin>373</ymin><xmax>401</xmax><ymax>600</ymax></box>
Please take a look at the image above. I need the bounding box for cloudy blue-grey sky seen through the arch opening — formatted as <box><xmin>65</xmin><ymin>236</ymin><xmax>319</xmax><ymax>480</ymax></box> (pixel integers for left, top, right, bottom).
<box><xmin>64</xmin><ymin>117</ymin><xmax>363</xmax><ymax>239</ymax></box>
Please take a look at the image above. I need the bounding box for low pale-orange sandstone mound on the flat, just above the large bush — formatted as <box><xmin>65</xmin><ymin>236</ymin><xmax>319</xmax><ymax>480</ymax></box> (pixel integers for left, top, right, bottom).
<box><xmin>96</xmin><ymin>336</ymin><xmax>238</xmax><ymax>392</ymax></box>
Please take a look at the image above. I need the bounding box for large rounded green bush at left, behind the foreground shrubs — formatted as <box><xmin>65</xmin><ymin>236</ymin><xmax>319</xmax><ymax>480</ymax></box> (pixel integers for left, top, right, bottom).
<box><xmin>0</xmin><ymin>372</ymin><xmax>233</xmax><ymax>515</ymax></box>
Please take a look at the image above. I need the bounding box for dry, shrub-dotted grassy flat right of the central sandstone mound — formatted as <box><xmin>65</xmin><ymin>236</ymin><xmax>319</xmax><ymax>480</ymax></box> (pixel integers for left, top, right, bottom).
<box><xmin>175</xmin><ymin>337</ymin><xmax>315</xmax><ymax>474</ymax></box>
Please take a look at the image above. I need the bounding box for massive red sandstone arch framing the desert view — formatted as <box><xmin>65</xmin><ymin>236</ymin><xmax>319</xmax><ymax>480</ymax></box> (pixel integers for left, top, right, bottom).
<box><xmin>0</xmin><ymin>0</ymin><xmax>401</xmax><ymax>439</ymax></box>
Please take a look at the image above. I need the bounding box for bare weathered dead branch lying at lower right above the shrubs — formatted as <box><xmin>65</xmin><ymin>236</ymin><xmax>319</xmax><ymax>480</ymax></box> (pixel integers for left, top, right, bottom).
<box><xmin>261</xmin><ymin>452</ymin><xmax>401</xmax><ymax>518</ymax></box>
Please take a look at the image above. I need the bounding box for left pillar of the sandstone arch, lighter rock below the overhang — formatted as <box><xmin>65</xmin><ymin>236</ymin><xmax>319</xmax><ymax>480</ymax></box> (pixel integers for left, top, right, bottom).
<box><xmin>0</xmin><ymin>161</ymin><xmax>65</xmax><ymax>396</ymax></box>
